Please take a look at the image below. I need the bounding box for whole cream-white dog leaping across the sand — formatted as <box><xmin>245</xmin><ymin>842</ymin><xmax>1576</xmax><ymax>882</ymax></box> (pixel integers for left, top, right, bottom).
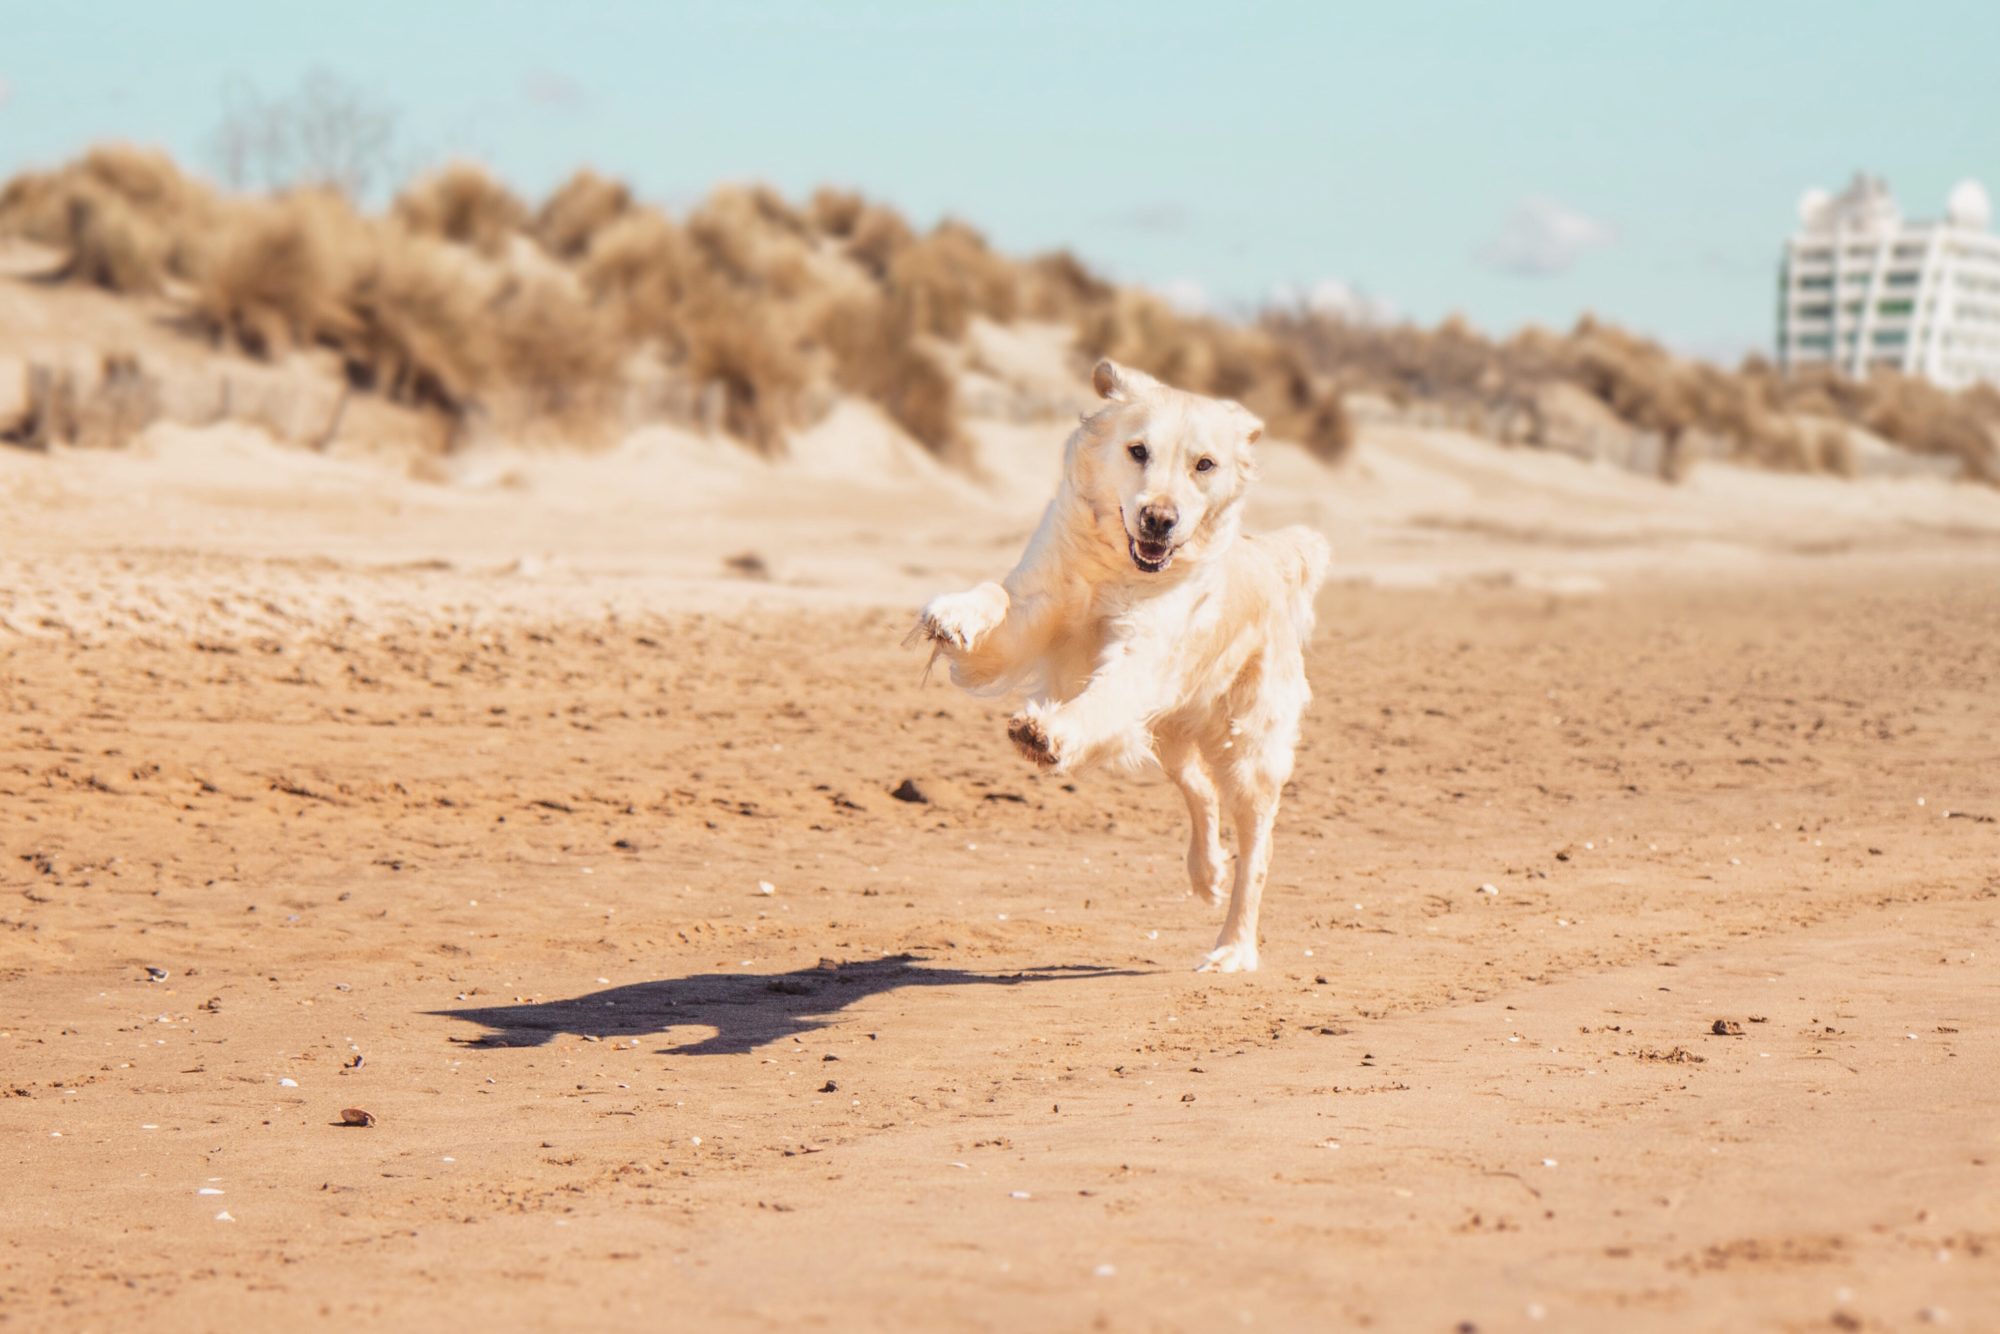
<box><xmin>910</xmin><ymin>362</ymin><xmax>1330</xmax><ymax>972</ymax></box>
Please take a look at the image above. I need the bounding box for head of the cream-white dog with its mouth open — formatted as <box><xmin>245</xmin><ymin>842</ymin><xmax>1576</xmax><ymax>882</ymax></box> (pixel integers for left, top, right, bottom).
<box><xmin>1070</xmin><ymin>360</ymin><xmax>1264</xmax><ymax>574</ymax></box>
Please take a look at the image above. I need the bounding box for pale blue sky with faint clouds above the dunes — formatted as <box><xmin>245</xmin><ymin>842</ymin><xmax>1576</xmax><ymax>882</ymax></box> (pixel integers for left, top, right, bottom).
<box><xmin>0</xmin><ymin>0</ymin><xmax>2000</xmax><ymax>356</ymax></box>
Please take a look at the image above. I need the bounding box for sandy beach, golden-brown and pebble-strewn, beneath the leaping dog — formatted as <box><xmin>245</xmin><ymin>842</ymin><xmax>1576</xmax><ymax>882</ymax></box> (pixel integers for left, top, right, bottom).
<box><xmin>0</xmin><ymin>408</ymin><xmax>2000</xmax><ymax>1330</ymax></box>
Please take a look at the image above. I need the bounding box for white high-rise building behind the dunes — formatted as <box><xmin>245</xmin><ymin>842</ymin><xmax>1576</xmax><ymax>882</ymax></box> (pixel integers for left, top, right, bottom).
<box><xmin>1778</xmin><ymin>176</ymin><xmax>2000</xmax><ymax>388</ymax></box>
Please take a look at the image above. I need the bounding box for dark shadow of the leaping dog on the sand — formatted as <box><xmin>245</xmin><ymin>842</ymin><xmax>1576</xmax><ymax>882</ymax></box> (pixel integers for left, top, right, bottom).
<box><xmin>432</xmin><ymin>954</ymin><xmax>1140</xmax><ymax>1056</ymax></box>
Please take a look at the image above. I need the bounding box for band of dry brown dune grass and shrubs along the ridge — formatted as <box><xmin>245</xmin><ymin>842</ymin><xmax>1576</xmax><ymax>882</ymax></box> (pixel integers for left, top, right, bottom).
<box><xmin>0</xmin><ymin>146</ymin><xmax>2000</xmax><ymax>478</ymax></box>
